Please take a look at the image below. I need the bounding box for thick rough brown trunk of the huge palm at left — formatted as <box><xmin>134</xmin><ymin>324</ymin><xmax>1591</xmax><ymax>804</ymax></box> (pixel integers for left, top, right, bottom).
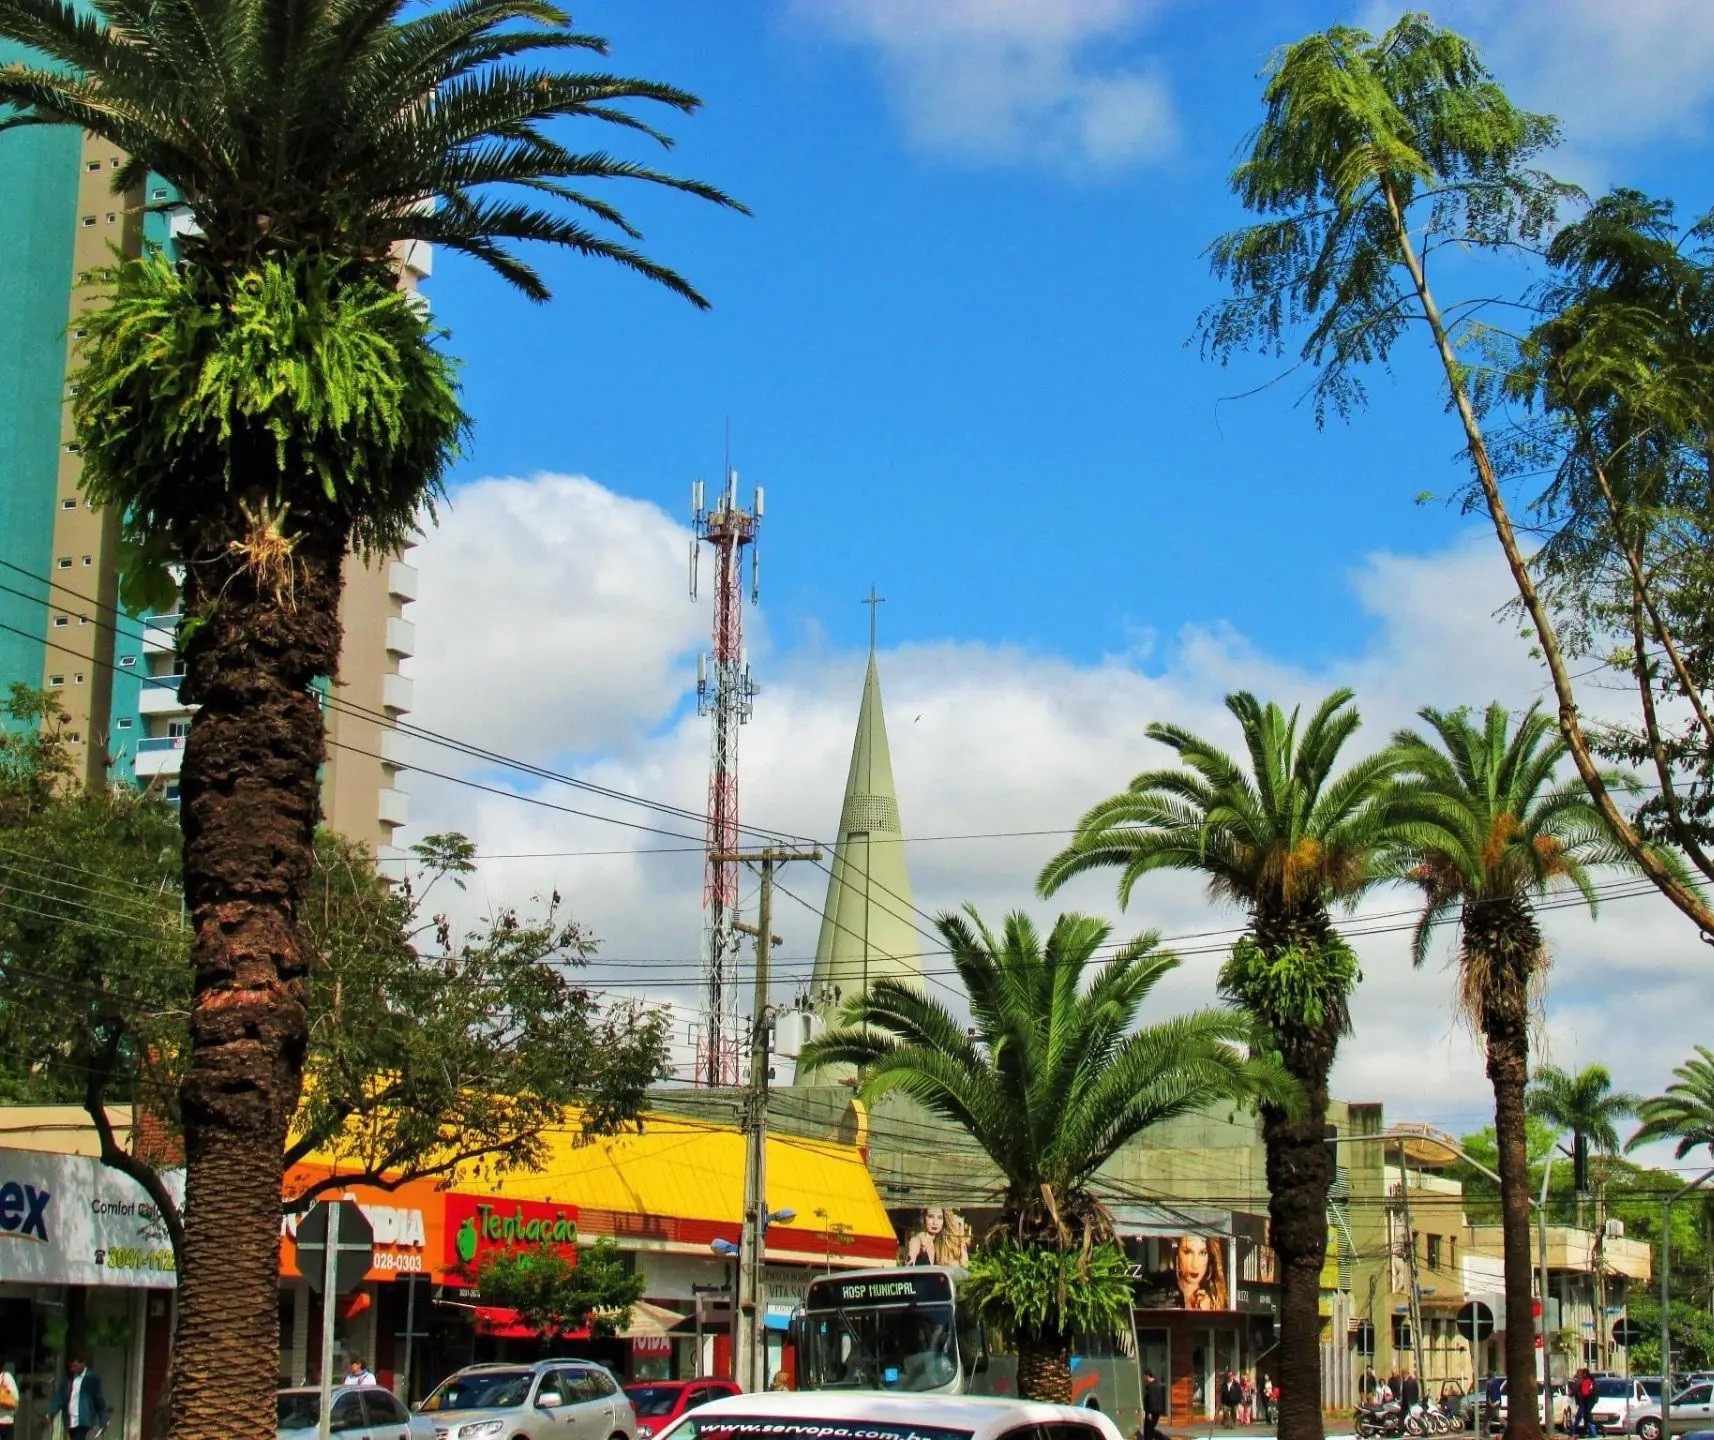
<box><xmin>170</xmin><ymin>521</ymin><xmax>345</xmax><ymax>1440</ymax></box>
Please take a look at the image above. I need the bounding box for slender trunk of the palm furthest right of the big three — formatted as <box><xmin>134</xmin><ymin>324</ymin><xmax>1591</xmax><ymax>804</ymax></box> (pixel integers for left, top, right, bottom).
<box><xmin>1464</xmin><ymin>905</ymin><xmax>1543</xmax><ymax>1440</ymax></box>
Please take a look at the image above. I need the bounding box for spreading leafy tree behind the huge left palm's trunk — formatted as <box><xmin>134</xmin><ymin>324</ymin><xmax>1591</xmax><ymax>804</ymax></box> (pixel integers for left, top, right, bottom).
<box><xmin>0</xmin><ymin>696</ymin><xmax>667</xmax><ymax>1250</ymax></box>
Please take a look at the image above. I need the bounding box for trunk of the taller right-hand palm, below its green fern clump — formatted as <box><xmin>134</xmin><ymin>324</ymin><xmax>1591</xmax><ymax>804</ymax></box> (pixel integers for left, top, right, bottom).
<box><xmin>1262</xmin><ymin>1037</ymin><xmax>1333</xmax><ymax>1440</ymax></box>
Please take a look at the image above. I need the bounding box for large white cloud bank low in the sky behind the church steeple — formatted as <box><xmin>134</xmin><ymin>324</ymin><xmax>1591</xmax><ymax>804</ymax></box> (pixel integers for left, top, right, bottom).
<box><xmin>394</xmin><ymin>477</ymin><xmax>1709</xmax><ymax>1131</ymax></box>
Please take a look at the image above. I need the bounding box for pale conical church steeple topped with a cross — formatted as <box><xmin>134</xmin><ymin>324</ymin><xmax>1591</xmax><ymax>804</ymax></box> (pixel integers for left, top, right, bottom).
<box><xmin>812</xmin><ymin>586</ymin><xmax>922</xmax><ymax>999</ymax></box>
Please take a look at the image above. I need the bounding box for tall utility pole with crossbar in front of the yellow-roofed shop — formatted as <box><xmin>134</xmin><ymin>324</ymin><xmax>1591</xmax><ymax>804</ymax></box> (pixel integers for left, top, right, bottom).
<box><xmin>715</xmin><ymin>847</ymin><xmax>821</xmax><ymax>1390</ymax></box>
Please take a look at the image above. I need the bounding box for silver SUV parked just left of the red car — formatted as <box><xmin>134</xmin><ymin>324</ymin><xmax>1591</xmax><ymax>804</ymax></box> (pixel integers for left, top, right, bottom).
<box><xmin>411</xmin><ymin>1359</ymin><xmax>638</xmax><ymax>1440</ymax></box>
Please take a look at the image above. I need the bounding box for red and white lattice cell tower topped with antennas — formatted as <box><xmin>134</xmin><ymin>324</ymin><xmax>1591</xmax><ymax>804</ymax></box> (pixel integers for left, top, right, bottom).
<box><xmin>691</xmin><ymin>465</ymin><xmax>763</xmax><ymax>1085</ymax></box>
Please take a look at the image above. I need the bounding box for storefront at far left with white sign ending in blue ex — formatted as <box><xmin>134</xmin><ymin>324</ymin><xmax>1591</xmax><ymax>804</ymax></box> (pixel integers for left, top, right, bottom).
<box><xmin>0</xmin><ymin>1149</ymin><xmax>183</xmax><ymax>1440</ymax></box>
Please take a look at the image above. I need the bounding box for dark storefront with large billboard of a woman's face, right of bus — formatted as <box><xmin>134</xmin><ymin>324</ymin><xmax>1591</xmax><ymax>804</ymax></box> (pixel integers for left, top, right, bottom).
<box><xmin>1114</xmin><ymin>1205</ymin><xmax>1279</xmax><ymax>1423</ymax></box>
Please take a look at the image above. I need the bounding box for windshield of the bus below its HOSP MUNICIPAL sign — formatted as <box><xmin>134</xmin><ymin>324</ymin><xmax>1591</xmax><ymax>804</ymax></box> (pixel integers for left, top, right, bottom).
<box><xmin>799</xmin><ymin>1305</ymin><xmax>958</xmax><ymax>1390</ymax></box>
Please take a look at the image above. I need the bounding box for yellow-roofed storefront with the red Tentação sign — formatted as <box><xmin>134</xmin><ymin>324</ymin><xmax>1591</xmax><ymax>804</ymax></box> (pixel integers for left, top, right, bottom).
<box><xmin>281</xmin><ymin>1116</ymin><xmax>896</xmax><ymax>1399</ymax></box>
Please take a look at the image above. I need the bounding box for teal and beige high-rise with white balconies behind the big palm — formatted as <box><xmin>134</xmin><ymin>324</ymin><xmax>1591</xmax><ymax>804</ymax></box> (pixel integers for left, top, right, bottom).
<box><xmin>0</xmin><ymin>104</ymin><xmax>429</xmax><ymax>855</ymax></box>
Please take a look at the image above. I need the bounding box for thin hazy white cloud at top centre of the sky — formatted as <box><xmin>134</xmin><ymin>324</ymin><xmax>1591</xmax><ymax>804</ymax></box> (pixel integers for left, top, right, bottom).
<box><xmin>792</xmin><ymin>0</ymin><xmax>1178</xmax><ymax>170</ymax></box>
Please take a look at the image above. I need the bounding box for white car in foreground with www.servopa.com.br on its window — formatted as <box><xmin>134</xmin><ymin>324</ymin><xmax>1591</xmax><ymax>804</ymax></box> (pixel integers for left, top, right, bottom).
<box><xmin>660</xmin><ymin>1390</ymin><xmax>1124</xmax><ymax>1440</ymax></box>
